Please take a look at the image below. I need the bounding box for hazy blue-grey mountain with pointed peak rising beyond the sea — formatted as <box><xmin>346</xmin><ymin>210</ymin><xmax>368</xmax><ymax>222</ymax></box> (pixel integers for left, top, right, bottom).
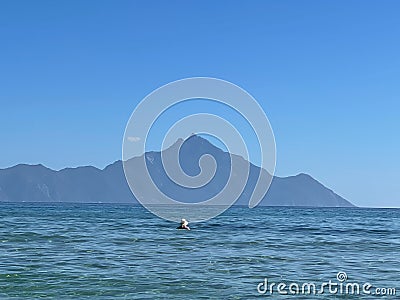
<box><xmin>0</xmin><ymin>135</ymin><xmax>354</xmax><ymax>207</ymax></box>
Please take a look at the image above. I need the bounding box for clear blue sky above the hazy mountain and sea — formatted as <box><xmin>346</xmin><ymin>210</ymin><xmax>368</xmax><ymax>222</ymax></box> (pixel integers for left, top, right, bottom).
<box><xmin>0</xmin><ymin>0</ymin><xmax>400</xmax><ymax>207</ymax></box>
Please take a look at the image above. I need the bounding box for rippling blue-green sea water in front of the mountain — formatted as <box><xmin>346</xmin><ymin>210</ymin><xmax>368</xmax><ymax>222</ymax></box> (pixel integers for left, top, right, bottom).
<box><xmin>0</xmin><ymin>203</ymin><xmax>400</xmax><ymax>299</ymax></box>
